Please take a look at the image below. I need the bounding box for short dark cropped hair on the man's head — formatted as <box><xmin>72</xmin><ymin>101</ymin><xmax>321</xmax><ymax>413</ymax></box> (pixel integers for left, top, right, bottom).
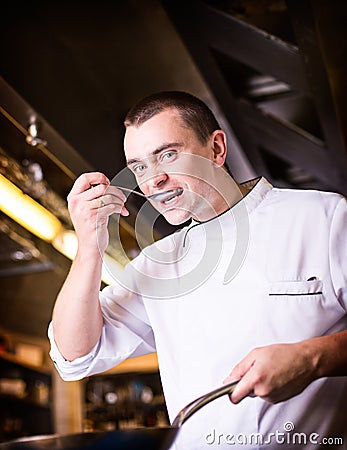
<box><xmin>124</xmin><ymin>91</ymin><xmax>220</xmax><ymax>143</ymax></box>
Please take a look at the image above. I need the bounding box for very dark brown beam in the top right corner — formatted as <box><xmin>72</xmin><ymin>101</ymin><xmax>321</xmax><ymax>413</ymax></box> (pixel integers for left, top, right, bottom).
<box><xmin>286</xmin><ymin>0</ymin><xmax>347</xmax><ymax>169</ymax></box>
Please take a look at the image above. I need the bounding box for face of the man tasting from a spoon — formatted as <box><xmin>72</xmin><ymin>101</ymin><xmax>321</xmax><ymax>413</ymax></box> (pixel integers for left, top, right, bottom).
<box><xmin>124</xmin><ymin>109</ymin><xmax>228</xmax><ymax>225</ymax></box>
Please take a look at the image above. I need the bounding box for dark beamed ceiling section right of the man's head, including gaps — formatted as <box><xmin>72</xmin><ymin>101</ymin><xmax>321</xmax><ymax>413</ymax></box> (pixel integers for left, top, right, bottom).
<box><xmin>162</xmin><ymin>0</ymin><xmax>347</xmax><ymax>194</ymax></box>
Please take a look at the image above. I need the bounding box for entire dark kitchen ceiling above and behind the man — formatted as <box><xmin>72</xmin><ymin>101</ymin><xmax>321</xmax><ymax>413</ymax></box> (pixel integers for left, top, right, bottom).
<box><xmin>0</xmin><ymin>0</ymin><xmax>347</xmax><ymax>337</ymax></box>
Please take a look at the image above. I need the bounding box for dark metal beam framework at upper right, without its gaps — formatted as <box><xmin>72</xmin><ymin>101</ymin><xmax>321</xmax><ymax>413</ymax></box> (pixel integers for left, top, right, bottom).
<box><xmin>162</xmin><ymin>0</ymin><xmax>347</xmax><ymax>193</ymax></box>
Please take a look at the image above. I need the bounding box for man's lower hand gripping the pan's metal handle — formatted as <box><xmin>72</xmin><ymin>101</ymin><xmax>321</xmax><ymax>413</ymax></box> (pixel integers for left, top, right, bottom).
<box><xmin>224</xmin><ymin>341</ymin><xmax>318</xmax><ymax>403</ymax></box>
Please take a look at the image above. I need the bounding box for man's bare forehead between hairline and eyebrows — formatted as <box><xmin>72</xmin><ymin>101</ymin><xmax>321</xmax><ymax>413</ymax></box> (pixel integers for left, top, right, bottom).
<box><xmin>124</xmin><ymin>109</ymin><xmax>195</xmax><ymax>160</ymax></box>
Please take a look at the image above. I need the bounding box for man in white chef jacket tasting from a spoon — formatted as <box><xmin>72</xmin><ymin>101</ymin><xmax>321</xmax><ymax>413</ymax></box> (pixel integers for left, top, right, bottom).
<box><xmin>49</xmin><ymin>92</ymin><xmax>347</xmax><ymax>450</ymax></box>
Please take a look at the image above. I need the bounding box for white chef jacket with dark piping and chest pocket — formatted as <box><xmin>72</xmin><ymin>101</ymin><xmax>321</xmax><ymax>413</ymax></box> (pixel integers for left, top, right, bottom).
<box><xmin>49</xmin><ymin>178</ymin><xmax>347</xmax><ymax>450</ymax></box>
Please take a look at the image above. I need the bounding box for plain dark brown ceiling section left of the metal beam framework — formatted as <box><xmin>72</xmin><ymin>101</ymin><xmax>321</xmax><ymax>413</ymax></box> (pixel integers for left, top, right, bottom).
<box><xmin>0</xmin><ymin>0</ymin><xmax>230</xmax><ymax>337</ymax></box>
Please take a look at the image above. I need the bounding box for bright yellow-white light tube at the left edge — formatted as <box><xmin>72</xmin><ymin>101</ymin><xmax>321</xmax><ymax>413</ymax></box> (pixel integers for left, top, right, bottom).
<box><xmin>0</xmin><ymin>174</ymin><xmax>62</xmax><ymax>242</ymax></box>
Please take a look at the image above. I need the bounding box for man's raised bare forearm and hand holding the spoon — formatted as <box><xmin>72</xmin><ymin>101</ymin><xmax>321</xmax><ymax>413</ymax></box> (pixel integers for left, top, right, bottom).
<box><xmin>53</xmin><ymin>172</ymin><xmax>128</xmax><ymax>361</ymax></box>
